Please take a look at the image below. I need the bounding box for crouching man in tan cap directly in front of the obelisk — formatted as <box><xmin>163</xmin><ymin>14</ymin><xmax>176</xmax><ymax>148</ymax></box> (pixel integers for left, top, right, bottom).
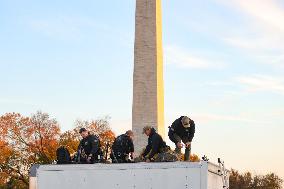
<box><xmin>142</xmin><ymin>126</ymin><xmax>168</xmax><ymax>162</ymax></box>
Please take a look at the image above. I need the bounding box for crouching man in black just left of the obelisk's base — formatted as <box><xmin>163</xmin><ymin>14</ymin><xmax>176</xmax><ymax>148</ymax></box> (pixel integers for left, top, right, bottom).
<box><xmin>110</xmin><ymin>130</ymin><xmax>134</xmax><ymax>163</ymax></box>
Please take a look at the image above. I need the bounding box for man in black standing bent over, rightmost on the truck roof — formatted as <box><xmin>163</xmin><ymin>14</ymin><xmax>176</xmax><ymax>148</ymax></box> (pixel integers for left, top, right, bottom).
<box><xmin>168</xmin><ymin>116</ymin><xmax>195</xmax><ymax>161</ymax></box>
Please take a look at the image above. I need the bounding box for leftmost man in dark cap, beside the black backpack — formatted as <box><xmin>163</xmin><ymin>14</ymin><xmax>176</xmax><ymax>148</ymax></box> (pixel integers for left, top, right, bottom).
<box><xmin>78</xmin><ymin>128</ymin><xmax>102</xmax><ymax>163</ymax></box>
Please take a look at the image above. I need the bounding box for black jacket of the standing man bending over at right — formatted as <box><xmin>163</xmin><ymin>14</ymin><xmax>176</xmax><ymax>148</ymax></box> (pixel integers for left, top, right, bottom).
<box><xmin>168</xmin><ymin>116</ymin><xmax>195</xmax><ymax>144</ymax></box>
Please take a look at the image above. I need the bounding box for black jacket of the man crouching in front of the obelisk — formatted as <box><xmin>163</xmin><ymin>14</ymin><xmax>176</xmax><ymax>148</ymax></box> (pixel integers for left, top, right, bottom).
<box><xmin>142</xmin><ymin>128</ymin><xmax>167</xmax><ymax>159</ymax></box>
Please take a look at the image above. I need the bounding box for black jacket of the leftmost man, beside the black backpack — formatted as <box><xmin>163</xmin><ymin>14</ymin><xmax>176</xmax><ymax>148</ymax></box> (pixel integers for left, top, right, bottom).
<box><xmin>78</xmin><ymin>134</ymin><xmax>101</xmax><ymax>159</ymax></box>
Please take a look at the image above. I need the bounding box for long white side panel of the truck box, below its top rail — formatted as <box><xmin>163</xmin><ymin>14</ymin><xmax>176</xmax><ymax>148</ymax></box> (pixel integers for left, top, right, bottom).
<box><xmin>38</xmin><ymin>168</ymin><xmax>200</xmax><ymax>189</ymax></box>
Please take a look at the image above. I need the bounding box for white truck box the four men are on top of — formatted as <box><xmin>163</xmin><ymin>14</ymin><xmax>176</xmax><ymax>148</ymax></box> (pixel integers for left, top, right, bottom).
<box><xmin>37</xmin><ymin>162</ymin><xmax>226</xmax><ymax>189</ymax></box>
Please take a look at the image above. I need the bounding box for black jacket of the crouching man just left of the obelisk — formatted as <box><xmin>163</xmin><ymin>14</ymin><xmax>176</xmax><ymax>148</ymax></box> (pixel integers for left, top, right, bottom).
<box><xmin>112</xmin><ymin>134</ymin><xmax>134</xmax><ymax>154</ymax></box>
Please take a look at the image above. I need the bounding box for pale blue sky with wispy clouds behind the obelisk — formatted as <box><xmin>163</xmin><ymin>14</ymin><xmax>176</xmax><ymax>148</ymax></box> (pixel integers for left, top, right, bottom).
<box><xmin>0</xmin><ymin>0</ymin><xmax>284</xmax><ymax>180</ymax></box>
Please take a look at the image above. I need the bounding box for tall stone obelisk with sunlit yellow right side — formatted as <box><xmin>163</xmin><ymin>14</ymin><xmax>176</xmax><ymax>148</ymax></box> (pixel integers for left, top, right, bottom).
<box><xmin>132</xmin><ymin>0</ymin><xmax>165</xmax><ymax>154</ymax></box>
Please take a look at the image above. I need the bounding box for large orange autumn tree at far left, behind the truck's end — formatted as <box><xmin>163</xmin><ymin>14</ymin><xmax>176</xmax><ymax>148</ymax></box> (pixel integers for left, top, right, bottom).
<box><xmin>0</xmin><ymin>111</ymin><xmax>60</xmax><ymax>188</ymax></box>
